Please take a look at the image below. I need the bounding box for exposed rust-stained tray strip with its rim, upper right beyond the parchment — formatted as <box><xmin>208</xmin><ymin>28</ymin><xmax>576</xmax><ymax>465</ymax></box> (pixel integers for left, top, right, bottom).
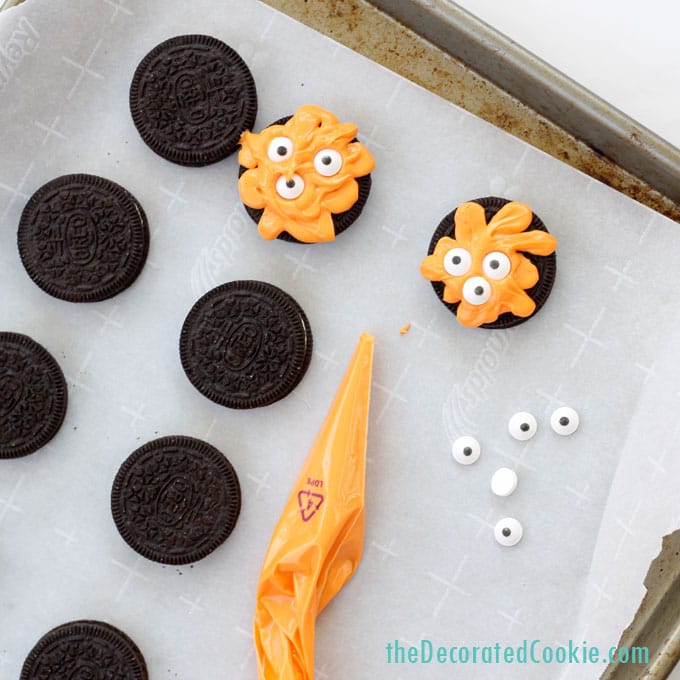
<box><xmin>262</xmin><ymin>0</ymin><xmax>680</xmax><ymax>222</ymax></box>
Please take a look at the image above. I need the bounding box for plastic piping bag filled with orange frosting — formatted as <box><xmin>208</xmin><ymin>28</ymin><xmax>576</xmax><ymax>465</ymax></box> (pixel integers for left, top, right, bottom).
<box><xmin>254</xmin><ymin>333</ymin><xmax>373</xmax><ymax>680</ymax></box>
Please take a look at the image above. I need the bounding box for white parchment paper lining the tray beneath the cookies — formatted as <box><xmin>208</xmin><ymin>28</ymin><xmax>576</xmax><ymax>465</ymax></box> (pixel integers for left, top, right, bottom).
<box><xmin>0</xmin><ymin>0</ymin><xmax>680</xmax><ymax>680</ymax></box>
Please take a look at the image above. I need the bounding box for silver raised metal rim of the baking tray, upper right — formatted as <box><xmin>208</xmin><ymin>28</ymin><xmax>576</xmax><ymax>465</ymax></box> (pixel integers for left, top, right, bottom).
<box><xmin>371</xmin><ymin>0</ymin><xmax>680</xmax><ymax>203</ymax></box>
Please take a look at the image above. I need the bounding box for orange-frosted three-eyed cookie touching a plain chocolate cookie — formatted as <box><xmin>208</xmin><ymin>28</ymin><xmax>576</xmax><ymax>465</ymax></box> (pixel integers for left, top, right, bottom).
<box><xmin>238</xmin><ymin>105</ymin><xmax>375</xmax><ymax>243</ymax></box>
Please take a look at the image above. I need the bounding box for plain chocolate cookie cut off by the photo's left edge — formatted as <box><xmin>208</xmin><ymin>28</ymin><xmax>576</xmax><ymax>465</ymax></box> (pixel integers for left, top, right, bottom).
<box><xmin>0</xmin><ymin>332</ymin><xmax>68</xmax><ymax>458</ymax></box>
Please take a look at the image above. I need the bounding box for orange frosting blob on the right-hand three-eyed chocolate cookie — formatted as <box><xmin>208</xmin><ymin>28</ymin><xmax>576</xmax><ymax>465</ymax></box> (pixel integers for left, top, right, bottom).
<box><xmin>420</xmin><ymin>201</ymin><xmax>557</xmax><ymax>327</ymax></box>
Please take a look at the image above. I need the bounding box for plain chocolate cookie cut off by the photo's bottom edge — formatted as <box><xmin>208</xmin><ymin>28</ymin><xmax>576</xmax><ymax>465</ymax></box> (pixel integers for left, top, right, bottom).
<box><xmin>19</xmin><ymin>621</ymin><xmax>149</xmax><ymax>680</ymax></box>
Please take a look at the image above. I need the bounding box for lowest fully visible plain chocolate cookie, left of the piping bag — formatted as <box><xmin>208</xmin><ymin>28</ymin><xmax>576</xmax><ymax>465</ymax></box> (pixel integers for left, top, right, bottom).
<box><xmin>111</xmin><ymin>436</ymin><xmax>241</xmax><ymax>564</ymax></box>
